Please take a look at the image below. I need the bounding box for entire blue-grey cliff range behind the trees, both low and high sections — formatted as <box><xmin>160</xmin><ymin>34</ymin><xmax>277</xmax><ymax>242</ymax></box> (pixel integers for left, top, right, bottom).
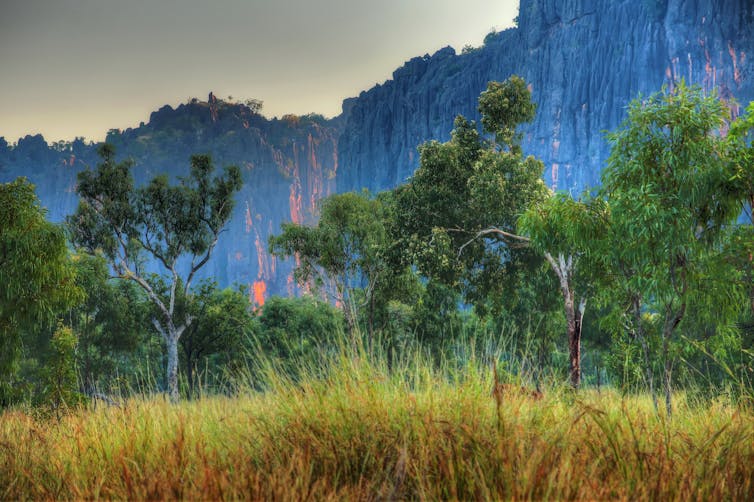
<box><xmin>0</xmin><ymin>0</ymin><xmax>754</xmax><ymax>296</ymax></box>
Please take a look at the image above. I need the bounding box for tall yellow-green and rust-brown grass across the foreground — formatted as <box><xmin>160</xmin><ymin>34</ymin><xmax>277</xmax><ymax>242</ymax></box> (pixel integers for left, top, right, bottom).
<box><xmin>0</xmin><ymin>348</ymin><xmax>754</xmax><ymax>500</ymax></box>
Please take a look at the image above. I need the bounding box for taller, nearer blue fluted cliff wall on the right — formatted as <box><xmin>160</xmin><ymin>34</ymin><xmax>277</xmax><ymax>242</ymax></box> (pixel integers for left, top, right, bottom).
<box><xmin>337</xmin><ymin>0</ymin><xmax>754</xmax><ymax>194</ymax></box>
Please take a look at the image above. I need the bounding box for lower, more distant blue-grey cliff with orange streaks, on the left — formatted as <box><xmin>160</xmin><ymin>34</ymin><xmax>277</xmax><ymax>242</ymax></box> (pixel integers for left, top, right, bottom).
<box><xmin>0</xmin><ymin>94</ymin><xmax>342</xmax><ymax>304</ymax></box>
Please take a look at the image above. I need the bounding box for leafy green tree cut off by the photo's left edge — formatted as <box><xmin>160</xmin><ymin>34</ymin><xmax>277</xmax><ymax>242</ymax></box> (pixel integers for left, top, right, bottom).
<box><xmin>0</xmin><ymin>178</ymin><xmax>81</xmax><ymax>405</ymax></box>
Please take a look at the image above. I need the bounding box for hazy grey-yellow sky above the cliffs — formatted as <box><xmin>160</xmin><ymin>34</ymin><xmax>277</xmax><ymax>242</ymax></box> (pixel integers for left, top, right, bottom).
<box><xmin>0</xmin><ymin>0</ymin><xmax>518</xmax><ymax>143</ymax></box>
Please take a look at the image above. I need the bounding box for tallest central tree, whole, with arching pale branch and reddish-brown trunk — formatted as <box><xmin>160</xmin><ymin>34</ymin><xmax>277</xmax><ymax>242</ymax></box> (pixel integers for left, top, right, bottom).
<box><xmin>396</xmin><ymin>75</ymin><xmax>602</xmax><ymax>387</ymax></box>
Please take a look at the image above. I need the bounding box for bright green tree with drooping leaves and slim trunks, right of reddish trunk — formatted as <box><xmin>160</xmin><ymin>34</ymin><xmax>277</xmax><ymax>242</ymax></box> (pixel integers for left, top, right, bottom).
<box><xmin>603</xmin><ymin>83</ymin><xmax>741</xmax><ymax>414</ymax></box>
